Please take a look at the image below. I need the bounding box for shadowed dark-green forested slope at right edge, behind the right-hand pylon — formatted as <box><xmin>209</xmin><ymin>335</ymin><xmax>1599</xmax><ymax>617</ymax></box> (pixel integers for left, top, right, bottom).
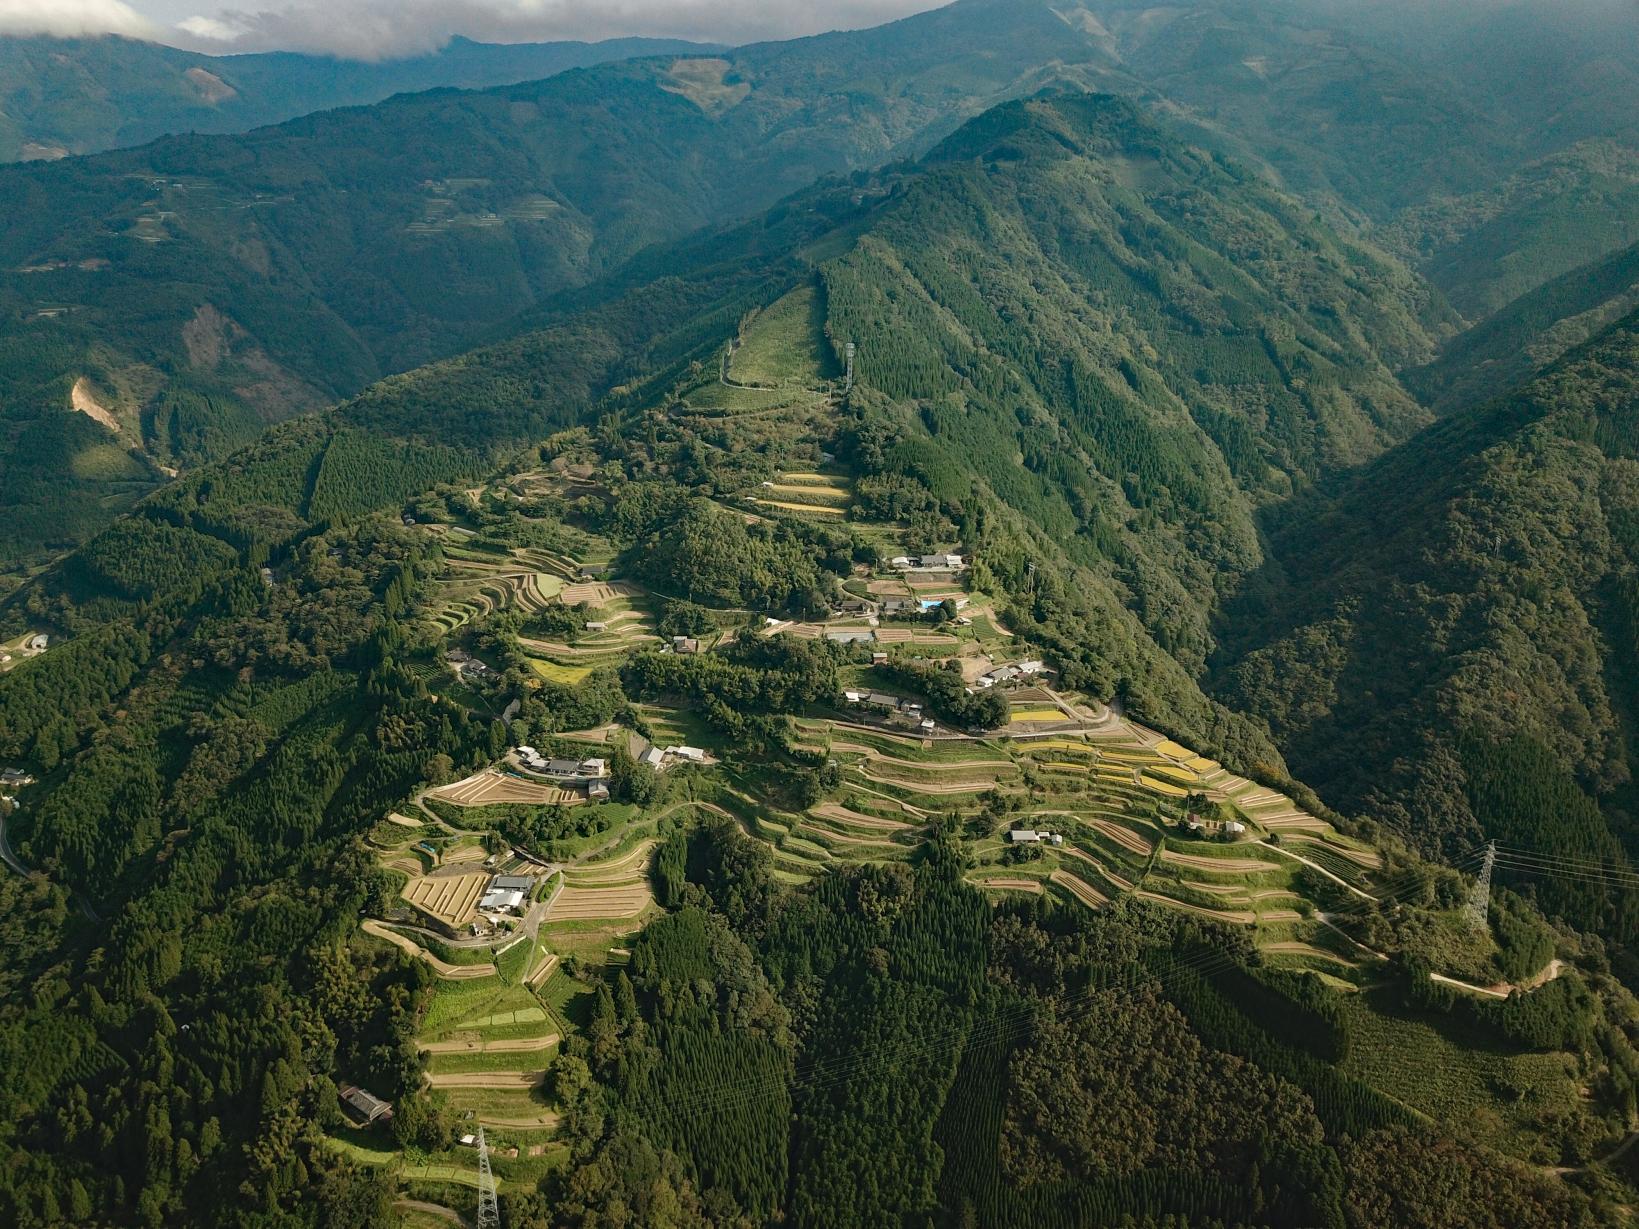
<box><xmin>1214</xmin><ymin>315</ymin><xmax>1639</xmax><ymax>936</ymax></box>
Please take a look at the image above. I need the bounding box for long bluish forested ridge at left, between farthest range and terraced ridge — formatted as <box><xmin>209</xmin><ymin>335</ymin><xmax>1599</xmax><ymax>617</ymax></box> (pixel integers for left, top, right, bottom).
<box><xmin>0</xmin><ymin>0</ymin><xmax>1121</xmax><ymax>570</ymax></box>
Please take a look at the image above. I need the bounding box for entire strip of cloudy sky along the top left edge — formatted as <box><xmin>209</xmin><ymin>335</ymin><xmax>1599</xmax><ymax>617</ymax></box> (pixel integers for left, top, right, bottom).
<box><xmin>0</xmin><ymin>0</ymin><xmax>947</xmax><ymax>59</ymax></box>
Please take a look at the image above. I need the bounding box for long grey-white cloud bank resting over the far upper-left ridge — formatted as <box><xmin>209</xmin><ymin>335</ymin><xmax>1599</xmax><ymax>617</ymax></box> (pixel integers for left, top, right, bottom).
<box><xmin>163</xmin><ymin>0</ymin><xmax>947</xmax><ymax>59</ymax></box>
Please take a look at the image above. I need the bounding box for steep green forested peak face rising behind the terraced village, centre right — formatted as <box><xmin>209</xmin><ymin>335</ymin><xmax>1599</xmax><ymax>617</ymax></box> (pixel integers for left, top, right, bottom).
<box><xmin>821</xmin><ymin>95</ymin><xmax>1444</xmax><ymax>707</ymax></box>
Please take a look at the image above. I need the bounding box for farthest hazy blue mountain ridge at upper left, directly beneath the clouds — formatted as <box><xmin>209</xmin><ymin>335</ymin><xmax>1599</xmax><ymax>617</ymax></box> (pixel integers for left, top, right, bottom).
<box><xmin>0</xmin><ymin>34</ymin><xmax>715</xmax><ymax>162</ymax></box>
